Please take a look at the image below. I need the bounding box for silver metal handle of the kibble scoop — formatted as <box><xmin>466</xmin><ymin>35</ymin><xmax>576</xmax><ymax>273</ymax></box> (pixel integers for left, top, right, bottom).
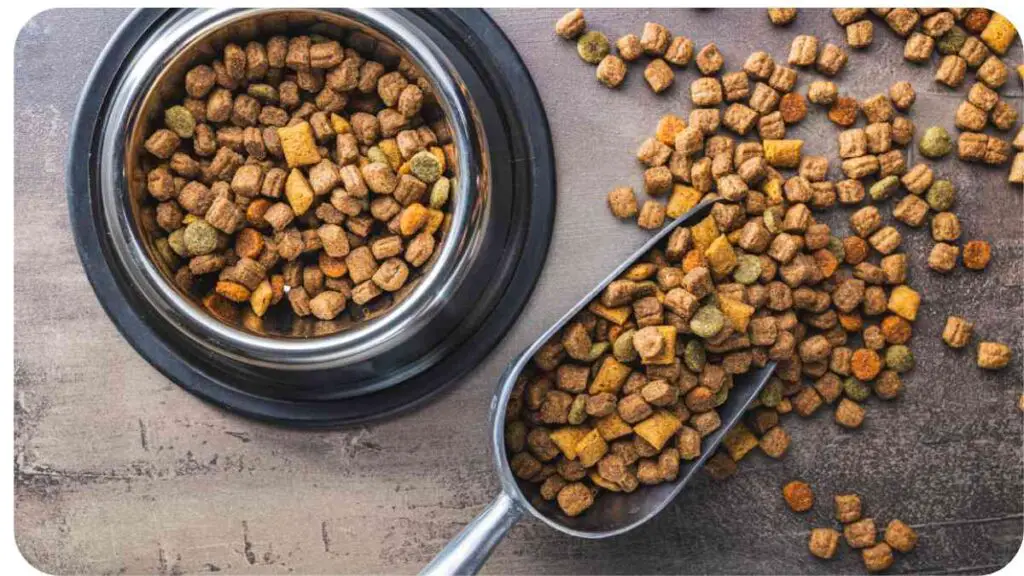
<box><xmin>420</xmin><ymin>492</ymin><xmax>523</xmax><ymax>576</ymax></box>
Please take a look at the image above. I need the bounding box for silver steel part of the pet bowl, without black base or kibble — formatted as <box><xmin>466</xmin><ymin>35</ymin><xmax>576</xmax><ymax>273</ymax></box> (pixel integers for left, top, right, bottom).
<box><xmin>99</xmin><ymin>8</ymin><xmax>489</xmax><ymax>369</ymax></box>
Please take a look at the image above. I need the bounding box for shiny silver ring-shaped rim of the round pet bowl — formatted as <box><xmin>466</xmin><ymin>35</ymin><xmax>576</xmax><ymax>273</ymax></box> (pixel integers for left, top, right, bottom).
<box><xmin>99</xmin><ymin>8</ymin><xmax>488</xmax><ymax>369</ymax></box>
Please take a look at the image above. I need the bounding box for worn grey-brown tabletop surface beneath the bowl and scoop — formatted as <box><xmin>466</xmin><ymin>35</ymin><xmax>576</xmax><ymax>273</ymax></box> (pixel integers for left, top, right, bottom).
<box><xmin>14</xmin><ymin>10</ymin><xmax>1024</xmax><ymax>574</ymax></box>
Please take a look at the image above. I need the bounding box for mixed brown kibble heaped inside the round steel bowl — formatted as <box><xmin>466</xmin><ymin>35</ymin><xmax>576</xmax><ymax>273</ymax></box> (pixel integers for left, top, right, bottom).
<box><xmin>143</xmin><ymin>34</ymin><xmax>455</xmax><ymax>328</ymax></box>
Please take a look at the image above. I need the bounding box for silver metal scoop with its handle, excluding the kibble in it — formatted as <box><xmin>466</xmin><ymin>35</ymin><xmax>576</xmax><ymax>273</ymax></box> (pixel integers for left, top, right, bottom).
<box><xmin>421</xmin><ymin>200</ymin><xmax>775</xmax><ymax>575</ymax></box>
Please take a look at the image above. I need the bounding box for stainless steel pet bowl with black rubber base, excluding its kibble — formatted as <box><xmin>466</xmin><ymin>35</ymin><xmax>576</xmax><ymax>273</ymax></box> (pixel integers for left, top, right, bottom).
<box><xmin>66</xmin><ymin>8</ymin><xmax>555</xmax><ymax>426</ymax></box>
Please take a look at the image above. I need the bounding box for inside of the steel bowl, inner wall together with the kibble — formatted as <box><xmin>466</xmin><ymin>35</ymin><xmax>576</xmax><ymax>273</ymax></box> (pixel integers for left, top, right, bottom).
<box><xmin>118</xmin><ymin>10</ymin><xmax>473</xmax><ymax>352</ymax></box>
